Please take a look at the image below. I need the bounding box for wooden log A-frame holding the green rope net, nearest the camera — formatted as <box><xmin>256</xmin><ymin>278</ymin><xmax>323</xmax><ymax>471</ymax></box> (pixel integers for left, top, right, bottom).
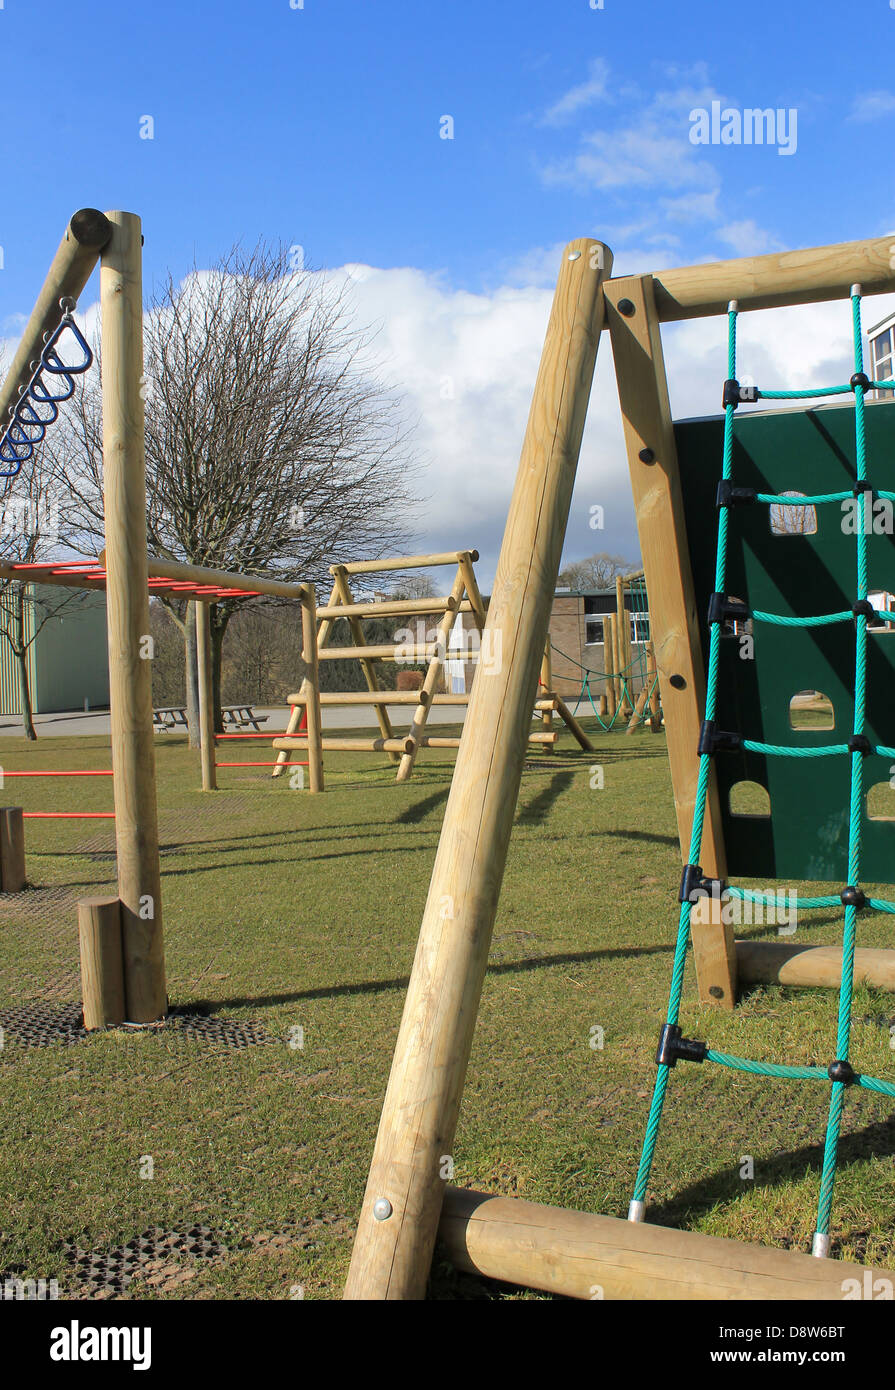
<box><xmin>345</xmin><ymin>230</ymin><xmax>895</xmax><ymax>1300</ymax></box>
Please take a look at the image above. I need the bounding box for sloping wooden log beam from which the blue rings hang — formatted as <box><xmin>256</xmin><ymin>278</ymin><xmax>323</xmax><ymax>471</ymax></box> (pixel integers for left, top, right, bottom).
<box><xmin>0</xmin><ymin>207</ymin><xmax>113</xmax><ymax>432</ymax></box>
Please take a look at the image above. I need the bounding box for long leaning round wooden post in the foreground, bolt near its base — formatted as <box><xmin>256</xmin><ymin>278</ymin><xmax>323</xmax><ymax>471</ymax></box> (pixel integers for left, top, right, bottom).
<box><xmin>345</xmin><ymin>239</ymin><xmax>611</xmax><ymax>1298</ymax></box>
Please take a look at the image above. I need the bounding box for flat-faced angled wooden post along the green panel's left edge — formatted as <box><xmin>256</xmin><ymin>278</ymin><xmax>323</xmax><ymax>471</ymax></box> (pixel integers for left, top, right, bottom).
<box><xmin>606</xmin><ymin>275</ymin><xmax>737</xmax><ymax>1009</ymax></box>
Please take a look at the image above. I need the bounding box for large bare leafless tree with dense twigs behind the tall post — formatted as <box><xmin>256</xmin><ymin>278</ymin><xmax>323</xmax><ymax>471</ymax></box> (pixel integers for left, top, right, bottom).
<box><xmin>56</xmin><ymin>243</ymin><xmax>416</xmax><ymax>727</ymax></box>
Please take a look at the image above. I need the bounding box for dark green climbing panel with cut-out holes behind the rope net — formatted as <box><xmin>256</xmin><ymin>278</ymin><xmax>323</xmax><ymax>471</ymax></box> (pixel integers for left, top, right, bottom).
<box><xmin>674</xmin><ymin>402</ymin><xmax>895</xmax><ymax>884</ymax></box>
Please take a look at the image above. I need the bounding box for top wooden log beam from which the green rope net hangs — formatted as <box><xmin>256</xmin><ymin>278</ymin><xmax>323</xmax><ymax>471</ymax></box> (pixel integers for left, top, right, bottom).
<box><xmin>619</xmin><ymin>236</ymin><xmax>895</xmax><ymax>322</ymax></box>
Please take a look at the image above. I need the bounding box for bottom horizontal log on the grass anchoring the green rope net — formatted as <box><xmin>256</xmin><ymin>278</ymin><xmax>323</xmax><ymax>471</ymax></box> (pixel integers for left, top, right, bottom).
<box><xmin>438</xmin><ymin>1187</ymin><xmax>864</xmax><ymax>1302</ymax></box>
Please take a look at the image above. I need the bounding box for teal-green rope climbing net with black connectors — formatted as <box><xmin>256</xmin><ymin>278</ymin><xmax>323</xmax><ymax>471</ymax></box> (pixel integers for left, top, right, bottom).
<box><xmin>630</xmin><ymin>286</ymin><xmax>895</xmax><ymax>1255</ymax></box>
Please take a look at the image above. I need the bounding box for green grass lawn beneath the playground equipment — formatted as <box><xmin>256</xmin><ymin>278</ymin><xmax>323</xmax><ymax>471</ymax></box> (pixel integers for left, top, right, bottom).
<box><xmin>0</xmin><ymin>721</ymin><xmax>895</xmax><ymax>1298</ymax></box>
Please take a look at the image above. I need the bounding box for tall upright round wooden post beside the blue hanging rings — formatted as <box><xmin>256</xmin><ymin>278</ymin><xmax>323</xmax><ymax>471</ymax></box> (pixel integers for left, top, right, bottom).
<box><xmin>100</xmin><ymin>213</ymin><xmax>167</xmax><ymax>1023</ymax></box>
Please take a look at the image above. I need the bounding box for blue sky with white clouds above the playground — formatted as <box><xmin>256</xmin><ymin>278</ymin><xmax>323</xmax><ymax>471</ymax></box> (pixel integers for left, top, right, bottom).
<box><xmin>0</xmin><ymin>0</ymin><xmax>895</xmax><ymax>581</ymax></box>
